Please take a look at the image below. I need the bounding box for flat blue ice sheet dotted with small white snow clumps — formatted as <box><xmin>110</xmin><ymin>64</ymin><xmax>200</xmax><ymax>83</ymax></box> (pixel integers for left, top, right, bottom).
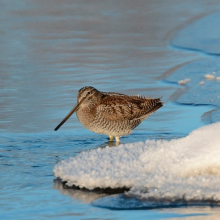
<box><xmin>165</xmin><ymin>58</ymin><xmax>220</xmax><ymax>106</ymax></box>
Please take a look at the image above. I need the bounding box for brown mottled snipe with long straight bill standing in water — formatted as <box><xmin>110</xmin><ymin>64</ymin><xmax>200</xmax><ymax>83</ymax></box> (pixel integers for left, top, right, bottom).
<box><xmin>54</xmin><ymin>86</ymin><xmax>164</xmax><ymax>142</ymax></box>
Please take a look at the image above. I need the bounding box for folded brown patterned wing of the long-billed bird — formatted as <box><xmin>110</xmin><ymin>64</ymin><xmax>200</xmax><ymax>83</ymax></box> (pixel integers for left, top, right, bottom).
<box><xmin>96</xmin><ymin>95</ymin><xmax>163</xmax><ymax>121</ymax></box>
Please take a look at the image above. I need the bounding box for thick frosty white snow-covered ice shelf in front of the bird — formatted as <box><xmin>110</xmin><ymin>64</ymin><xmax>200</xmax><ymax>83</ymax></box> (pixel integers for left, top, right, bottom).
<box><xmin>54</xmin><ymin>123</ymin><xmax>220</xmax><ymax>202</ymax></box>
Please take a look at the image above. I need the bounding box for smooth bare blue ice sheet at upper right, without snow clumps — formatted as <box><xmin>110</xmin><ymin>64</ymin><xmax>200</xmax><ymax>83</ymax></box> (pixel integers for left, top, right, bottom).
<box><xmin>171</xmin><ymin>12</ymin><xmax>220</xmax><ymax>54</ymax></box>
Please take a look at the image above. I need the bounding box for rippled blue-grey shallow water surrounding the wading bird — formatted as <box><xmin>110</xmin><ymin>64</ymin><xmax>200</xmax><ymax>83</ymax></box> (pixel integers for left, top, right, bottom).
<box><xmin>0</xmin><ymin>0</ymin><xmax>220</xmax><ymax>219</ymax></box>
